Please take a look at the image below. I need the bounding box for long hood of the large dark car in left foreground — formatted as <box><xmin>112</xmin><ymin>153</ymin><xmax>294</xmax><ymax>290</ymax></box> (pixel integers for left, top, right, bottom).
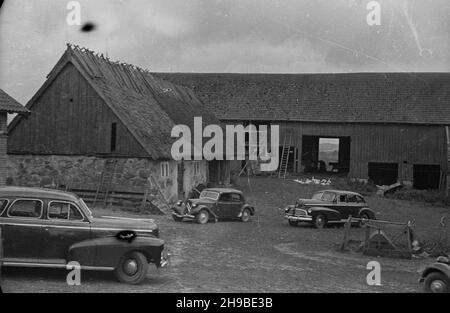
<box><xmin>91</xmin><ymin>216</ymin><xmax>158</xmax><ymax>232</ymax></box>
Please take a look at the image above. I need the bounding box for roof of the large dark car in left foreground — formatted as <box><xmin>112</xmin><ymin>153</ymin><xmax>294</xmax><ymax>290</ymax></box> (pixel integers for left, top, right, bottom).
<box><xmin>0</xmin><ymin>186</ymin><xmax>78</xmax><ymax>201</ymax></box>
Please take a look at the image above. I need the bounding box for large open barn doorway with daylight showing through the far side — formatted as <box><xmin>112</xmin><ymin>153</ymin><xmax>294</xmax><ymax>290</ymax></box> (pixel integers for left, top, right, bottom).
<box><xmin>301</xmin><ymin>136</ymin><xmax>351</xmax><ymax>174</ymax></box>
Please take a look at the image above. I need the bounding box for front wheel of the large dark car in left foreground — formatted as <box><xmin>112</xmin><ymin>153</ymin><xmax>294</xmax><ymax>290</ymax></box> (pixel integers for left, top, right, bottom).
<box><xmin>115</xmin><ymin>252</ymin><xmax>148</xmax><ymax>285</ymax></box>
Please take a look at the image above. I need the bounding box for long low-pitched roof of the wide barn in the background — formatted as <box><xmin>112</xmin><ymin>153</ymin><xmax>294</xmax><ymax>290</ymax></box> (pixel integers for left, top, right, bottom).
<box><xmin>154</xmin><ymin>73</ymin><xmax>450</xmax><ymax>124</ymax></box>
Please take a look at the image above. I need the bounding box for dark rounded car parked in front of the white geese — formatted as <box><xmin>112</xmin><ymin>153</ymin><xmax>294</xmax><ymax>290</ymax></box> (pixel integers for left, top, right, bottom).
<box><xmin>284</xmin><ymin>190</ymin><xmax>375</xmax><ymax>228</ymax></box>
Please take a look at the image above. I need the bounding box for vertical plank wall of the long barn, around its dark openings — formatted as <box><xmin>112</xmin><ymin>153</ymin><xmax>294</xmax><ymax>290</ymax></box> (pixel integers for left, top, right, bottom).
<box><xmin>224</xmin><ymin>121</ymin><xmax>447</xmax><ymax>181</ymax></box>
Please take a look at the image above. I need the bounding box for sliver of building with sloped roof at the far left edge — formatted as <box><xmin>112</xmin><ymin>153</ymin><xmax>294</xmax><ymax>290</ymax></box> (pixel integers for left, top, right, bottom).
<box><xmin>0</xmin><ymin>89</ymin><xmax>29</xmax><ymax>186</ymax></box>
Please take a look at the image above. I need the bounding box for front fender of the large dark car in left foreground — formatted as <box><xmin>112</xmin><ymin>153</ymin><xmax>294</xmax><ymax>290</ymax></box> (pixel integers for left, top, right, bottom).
<box><xmin>67</xmin><ymin>235</ymin><xmax>164</xmax><ymax>268</ymax></box>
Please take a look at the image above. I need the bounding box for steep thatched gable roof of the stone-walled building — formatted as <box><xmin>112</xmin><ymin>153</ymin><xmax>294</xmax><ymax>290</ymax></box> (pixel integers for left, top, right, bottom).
<box><xmin>12</xmin><ymin>44</ymin><xmax>220</xmax><ymax>159</ymax></box>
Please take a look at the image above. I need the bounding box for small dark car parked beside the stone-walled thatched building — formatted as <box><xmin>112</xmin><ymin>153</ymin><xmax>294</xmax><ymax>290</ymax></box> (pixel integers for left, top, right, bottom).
<box><xmin>172</xmin><ymin>188</ymin><xmax>255</xmax><ymax>224</ymax></box>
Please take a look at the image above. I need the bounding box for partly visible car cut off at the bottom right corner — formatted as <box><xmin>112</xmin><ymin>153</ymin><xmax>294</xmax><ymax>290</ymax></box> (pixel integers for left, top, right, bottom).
<box><xmin>419</xmin><ymin>256</ymin><xmax>450</xmax><ymax>293</ymax></box>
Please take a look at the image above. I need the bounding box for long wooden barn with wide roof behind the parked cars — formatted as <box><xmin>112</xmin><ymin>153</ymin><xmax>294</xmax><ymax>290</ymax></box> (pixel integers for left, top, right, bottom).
<box><xmin>155</xmin><ymin>73</ymin><xmax>450</xmax><ymax>189</ymax></box>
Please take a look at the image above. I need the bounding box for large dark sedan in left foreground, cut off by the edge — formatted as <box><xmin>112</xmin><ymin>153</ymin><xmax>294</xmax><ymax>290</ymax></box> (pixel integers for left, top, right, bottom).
<box><xmin>0</xmin><ymin>187</ymin><xmax>168</xmax><ymax>284</ymax></box>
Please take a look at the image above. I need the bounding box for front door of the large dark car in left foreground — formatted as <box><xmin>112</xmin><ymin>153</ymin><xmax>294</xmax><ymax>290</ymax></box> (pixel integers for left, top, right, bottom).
<box><xmin>40</xmin><ymin>201</ymin><xmax>91</xmax><ymax>264</ymax></box>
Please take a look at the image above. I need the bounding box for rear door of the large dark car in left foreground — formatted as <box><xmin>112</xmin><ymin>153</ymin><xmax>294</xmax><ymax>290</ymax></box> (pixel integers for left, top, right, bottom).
<box><xmin>0</xmin><ymin>198</ymin><xmax>44</xmax><ymax>263</ymax></box>
